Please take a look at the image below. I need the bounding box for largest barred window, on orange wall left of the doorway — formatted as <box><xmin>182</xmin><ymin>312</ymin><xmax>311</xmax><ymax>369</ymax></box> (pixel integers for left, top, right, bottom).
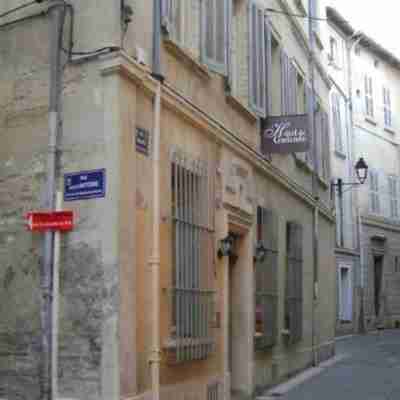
<box><xmin>171</xmin><ymin>151</ymin><xmax>214</xmax><ymax>363</ymax></box>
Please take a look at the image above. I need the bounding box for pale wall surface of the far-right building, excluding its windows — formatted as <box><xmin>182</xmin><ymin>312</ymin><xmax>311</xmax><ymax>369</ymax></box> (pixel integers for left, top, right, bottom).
<box><xmin>352</xmin><ymin>36</ymin><xmax>400</xmax><ymax>329</ymax></box>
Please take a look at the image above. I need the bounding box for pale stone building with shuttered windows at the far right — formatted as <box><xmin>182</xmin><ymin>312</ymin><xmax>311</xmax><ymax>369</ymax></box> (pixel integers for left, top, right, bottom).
<box><xmin>330</xmin><ymin>10</ymin><xmax>400</xmax><ymax>329</ymax></box>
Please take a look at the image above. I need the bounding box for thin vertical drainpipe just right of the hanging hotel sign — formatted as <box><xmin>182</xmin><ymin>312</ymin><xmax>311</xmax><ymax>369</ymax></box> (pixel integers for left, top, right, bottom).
<box><xmin>308</xmin><ymin>0</ymin><xmax>319</xmax><ymax>365</ymax></box>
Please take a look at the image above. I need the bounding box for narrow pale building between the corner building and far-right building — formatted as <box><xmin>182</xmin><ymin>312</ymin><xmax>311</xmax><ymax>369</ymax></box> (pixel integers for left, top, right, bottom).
<box><xmin>323</xmin><ymin>8</ymin><xmax>360</xmax><ymax>335</ymax></box>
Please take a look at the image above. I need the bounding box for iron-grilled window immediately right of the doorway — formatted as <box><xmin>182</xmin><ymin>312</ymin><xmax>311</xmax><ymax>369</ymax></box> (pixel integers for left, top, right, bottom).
<box><xmin>254</xmin><ymin>207</ymin><xmax>278</xmax><ymax>349</ymax></box>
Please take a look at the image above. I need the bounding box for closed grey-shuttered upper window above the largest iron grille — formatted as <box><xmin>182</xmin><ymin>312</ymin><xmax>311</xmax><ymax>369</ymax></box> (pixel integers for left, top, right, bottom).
<box><xmin>202</xmin><ymin>0</ymin><xmax>230</xmax><ymax>75</ymax></box>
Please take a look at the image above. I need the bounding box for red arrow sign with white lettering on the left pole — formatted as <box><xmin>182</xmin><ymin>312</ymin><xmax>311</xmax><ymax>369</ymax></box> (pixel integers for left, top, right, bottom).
<box><xmin>25</xmin><ymin>211</ymin><xmax>74</xmax><ymax>232</ymax></box>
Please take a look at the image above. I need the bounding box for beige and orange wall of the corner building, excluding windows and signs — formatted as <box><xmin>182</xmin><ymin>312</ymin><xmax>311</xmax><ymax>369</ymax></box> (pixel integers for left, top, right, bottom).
<box><xmin>0</xmin><ymin>1</ymin><xmax>336</xmax><ymax>400</ymax></box>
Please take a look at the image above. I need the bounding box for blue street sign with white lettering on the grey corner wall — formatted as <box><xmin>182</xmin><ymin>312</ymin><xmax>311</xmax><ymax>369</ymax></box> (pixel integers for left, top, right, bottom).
<box><xmin>64</xmin><ymin>169</ymin><xmax>106</xmax><ymax>201</ymax></box>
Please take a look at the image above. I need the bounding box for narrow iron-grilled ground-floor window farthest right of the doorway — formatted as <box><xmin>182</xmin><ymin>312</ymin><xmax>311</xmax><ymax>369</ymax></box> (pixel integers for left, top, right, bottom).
<box><xmin>284</xmin><ymin>222</ymin><xmax>303</xmax><ymax>344</ymax></box>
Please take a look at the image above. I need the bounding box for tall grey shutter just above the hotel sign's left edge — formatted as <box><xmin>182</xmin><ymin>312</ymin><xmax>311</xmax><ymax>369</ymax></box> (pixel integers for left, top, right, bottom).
<box><xmin>249</xmin><ymin>1</ymin><xmax>266</xmax><ymax>117</ymax></box>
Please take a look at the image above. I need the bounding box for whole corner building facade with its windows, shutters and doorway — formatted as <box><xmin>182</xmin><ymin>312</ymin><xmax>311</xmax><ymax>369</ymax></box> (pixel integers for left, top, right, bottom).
<box><xmin>0</xmin><ymin>0</ymin><xmax>336</xmax><ymax>400</ymax></box>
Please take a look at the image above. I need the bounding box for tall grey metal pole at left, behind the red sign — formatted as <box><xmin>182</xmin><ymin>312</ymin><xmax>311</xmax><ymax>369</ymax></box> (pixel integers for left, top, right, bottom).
<box><xmin>41</xmin><ymin>0</ymin><xmax>65</xmax><ymax>400</ymax></box>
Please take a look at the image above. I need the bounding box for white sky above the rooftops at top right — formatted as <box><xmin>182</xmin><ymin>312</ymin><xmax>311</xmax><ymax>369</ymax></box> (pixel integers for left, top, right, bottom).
<box><xmin>326</xmin><ymin>0</ymin><xmax>400</xmax><ymax>58</ymax></box>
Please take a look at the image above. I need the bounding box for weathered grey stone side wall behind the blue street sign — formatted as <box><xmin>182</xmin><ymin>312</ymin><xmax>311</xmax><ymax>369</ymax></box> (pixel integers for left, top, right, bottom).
<box><xmin>0</xmin><ymin>0</ymin><xmax>131</xmax><ymax>399</ymax></box>
